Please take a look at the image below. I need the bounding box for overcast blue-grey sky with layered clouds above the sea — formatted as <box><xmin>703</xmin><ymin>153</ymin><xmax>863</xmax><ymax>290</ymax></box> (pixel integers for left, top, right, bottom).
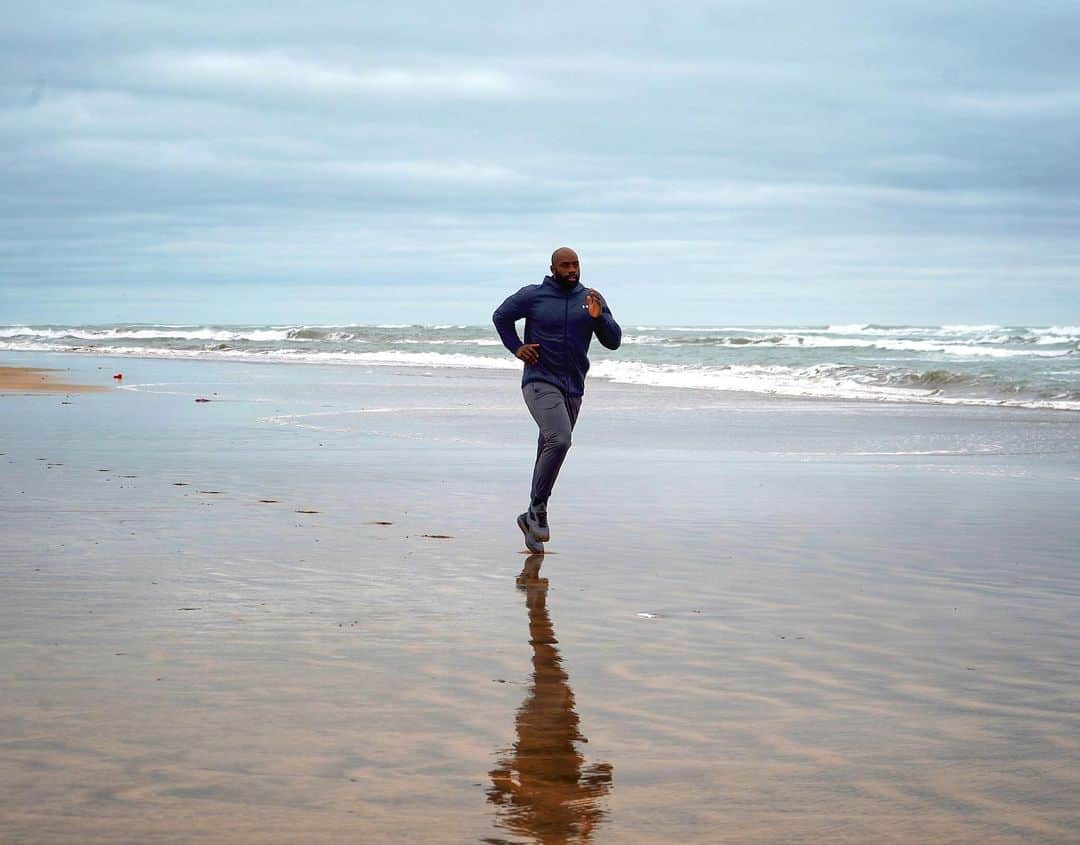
<box><xmin>0</xmin><ymin>0</ymin><xmax>1080</xmax><ymax>324</ymax></box>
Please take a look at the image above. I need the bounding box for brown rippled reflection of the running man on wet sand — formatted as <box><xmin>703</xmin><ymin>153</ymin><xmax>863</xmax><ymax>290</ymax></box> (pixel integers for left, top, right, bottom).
<box><xmin>487</xmin><ymin>554</ymin><xmax>611</xmax><ymax>845</ymax></box>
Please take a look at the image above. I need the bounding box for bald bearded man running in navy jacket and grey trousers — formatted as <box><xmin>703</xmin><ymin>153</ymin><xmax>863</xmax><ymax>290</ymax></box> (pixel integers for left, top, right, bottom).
<box><xmin>491</xmin><ymin>246</ymin><xmax>622</xmax><ymax>552</ymax></box>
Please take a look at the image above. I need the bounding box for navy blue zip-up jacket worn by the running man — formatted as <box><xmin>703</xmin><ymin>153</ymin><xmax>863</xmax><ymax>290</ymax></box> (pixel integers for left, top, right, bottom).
<box><xmin>491</xmin><ymin>276</ymin><xmax>622</xmax><ymax>397</ymax></box>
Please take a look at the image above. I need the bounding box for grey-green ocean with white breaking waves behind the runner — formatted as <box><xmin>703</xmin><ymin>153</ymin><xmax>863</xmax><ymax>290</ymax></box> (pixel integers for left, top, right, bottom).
<box><xmin>0</xmin><ymin>323</ymin><xmax>1080</xmax><ymax>411</ymax></box>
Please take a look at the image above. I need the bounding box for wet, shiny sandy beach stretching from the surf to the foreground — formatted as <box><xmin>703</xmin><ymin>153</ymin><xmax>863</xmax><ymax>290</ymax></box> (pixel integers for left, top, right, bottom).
<box><xmin>0</xmin><ymin>353</ymin><xmax>1080</xmax><ymax>845</ymax></box>
